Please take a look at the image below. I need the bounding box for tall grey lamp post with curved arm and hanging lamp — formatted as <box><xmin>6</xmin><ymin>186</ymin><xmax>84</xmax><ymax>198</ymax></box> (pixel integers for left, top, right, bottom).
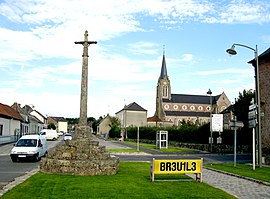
<box><xmin>226</xmin><ymin>44</ymin><xmax>262</xmax><ymax>167</ymax></box>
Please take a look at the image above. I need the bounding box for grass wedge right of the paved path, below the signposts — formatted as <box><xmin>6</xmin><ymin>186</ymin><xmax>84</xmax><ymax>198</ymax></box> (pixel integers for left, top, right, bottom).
<box><xmin>204</xmin><ymin>163</ymin><xmax>270</xmax><ymax>183</ymax></box>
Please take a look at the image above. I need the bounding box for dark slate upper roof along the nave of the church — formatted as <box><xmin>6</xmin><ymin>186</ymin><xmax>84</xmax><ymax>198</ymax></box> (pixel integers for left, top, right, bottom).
<box><xmin>162</xmin><ymin>94</ymin><xmax>220</xmax><ymax>104</ymax></box>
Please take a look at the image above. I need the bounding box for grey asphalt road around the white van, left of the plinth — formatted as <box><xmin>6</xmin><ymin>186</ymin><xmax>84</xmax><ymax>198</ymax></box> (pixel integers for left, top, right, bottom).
<box><xmin>0</xmin><ymin>138</ymin><xmax>63</xmax><ymax>187</ymax></box>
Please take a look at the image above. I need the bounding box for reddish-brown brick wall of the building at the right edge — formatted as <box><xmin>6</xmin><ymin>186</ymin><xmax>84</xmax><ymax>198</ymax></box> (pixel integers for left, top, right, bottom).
<box><xmin>259</xmin><ymin>62</ymin><xmax>270</xmax><ymax>148</ymax></box>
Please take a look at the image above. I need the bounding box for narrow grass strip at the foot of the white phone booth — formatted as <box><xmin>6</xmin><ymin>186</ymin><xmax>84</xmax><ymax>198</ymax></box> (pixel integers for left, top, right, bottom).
<box><xmin>125</xmin><ymin>141</ymin><xmax>197</xmax><ymax>153</ymax></box>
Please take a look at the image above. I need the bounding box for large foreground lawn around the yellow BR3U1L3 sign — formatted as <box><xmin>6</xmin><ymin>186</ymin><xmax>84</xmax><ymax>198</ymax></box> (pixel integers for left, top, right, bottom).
<box><xmin>2</xmin><ymin>162</ymin><xmax>234</xmax><ymax>199</ymax></box>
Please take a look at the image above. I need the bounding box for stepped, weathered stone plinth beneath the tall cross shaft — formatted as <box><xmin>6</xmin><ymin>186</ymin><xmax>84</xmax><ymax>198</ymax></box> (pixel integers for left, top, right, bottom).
<box><xmin>40</xmin><ymin>126</ymin><xmax>119</xmax><ymax>176</ymax></box>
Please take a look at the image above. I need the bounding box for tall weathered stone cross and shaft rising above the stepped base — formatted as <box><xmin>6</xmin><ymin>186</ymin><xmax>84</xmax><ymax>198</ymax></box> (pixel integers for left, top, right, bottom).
<box><xmin>74</xmin><ymin>30</ymin><xmax>97</xmax><ymax>126</ymax></box>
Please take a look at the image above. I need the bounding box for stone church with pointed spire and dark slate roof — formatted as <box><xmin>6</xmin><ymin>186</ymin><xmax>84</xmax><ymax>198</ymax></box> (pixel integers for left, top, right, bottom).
<box><xmin>153</xmin><ymin>52</ymin><xmax>231</xmax><ymax>126</ymax></box>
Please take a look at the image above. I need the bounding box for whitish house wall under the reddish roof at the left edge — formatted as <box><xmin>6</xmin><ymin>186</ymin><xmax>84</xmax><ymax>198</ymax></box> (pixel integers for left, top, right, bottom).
<box><xmin>0</xmin><ymin>118</ymin><xmax>21</xmax><ymax>135</ymax></box>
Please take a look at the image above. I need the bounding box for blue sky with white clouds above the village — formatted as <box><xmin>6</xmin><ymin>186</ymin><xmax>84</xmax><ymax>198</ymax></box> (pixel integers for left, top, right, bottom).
<box><xmin>0</xmin><ymin>0</ymin><xmax>270</xmax><ymax>118</ymax></box>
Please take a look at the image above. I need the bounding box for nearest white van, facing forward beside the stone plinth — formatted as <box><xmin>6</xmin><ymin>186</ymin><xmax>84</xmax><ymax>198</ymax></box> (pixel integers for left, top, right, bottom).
<box><xmin>10</xmin><ymin>135</ymin><xmax>48</xmax><ymax>162</ymax></box>
